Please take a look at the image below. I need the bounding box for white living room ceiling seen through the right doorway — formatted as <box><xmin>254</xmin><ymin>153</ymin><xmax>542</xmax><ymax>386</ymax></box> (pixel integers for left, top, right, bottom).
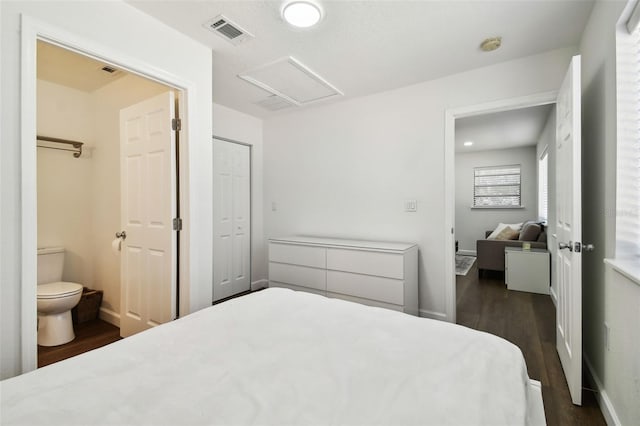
<box><xmin>455</xmin><ymin>104</ymin><xmax>554</xmax><ymax>153</ymax></box>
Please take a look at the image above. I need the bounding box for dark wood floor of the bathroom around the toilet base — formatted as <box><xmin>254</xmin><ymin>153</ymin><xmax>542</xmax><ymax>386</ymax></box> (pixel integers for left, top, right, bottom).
<box><xmin>38</xmin><ymin>319</ymin><xmax>121</xmax><ymax>367</ymax></box>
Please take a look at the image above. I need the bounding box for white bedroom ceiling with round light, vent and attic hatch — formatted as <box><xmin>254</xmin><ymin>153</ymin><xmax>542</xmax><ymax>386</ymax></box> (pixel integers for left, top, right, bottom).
<box><xmin>128</xmin><ymin>0</ymin><xmax>593</xmax><ymax>117</ymax></box>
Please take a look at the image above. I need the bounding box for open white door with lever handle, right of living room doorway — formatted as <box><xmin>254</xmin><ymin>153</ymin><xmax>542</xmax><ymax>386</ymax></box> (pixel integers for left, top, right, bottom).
<box><xmin>556</xmin><ymin>56</ymin><xmax>582</xmax><ymax>405</ymax></box>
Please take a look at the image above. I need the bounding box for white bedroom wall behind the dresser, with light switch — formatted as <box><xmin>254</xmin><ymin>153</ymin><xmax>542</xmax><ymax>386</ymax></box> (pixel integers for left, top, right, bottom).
<box><xmin>264</xmin><ymin>48</ymin><xmax>574</xmax><ymax>318</ymax></box>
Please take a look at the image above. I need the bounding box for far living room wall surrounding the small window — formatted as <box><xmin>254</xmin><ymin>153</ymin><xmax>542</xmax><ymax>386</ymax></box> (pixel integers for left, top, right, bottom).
<box><xmin>455</xmin><ymin>146</ymin><xmax>538</xmax><ymax>253</ymax></box>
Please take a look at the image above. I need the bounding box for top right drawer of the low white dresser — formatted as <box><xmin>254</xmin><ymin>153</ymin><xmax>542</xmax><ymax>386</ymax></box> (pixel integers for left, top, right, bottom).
<box><xmin>327</xmin><ymin>248</ymin><xmax>404</xmax><ymax>279</ymax></box>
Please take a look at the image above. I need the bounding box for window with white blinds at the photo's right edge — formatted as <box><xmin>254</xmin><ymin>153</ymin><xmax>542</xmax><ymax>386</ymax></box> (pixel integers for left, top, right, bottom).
<box><xmin>616</xmin><ymin>3</ymin><xmax>640</xmax><ymax>257</ymax></box>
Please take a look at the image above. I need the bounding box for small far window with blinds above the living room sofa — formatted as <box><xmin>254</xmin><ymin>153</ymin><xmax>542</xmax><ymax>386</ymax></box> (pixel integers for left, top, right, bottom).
<box><xmin>473</xmin><ymin>165</ymin><xmax>521</xmax><ymax>208</ymax></box>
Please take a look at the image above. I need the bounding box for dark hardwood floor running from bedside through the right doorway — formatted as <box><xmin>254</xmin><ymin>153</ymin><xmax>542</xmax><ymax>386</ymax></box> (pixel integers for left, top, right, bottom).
<box><xmin>456</xmin><ymin>264</ymin><xmax>606</xmax><ymax>426</ymax></box>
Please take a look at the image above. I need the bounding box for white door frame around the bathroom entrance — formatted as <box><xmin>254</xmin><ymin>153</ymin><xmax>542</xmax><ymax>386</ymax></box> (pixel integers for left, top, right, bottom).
<box><xmin>20</xmin><ymin>15</ymin><xmax>195</xmax><ymax>373</ymax></box>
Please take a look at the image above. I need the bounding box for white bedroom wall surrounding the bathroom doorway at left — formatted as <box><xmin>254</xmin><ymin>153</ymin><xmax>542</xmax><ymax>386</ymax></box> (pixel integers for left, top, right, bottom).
<box><xmin>0</xmin><ymin>1</ymin><xmax>212</xmax><ymax>378</ymax></box>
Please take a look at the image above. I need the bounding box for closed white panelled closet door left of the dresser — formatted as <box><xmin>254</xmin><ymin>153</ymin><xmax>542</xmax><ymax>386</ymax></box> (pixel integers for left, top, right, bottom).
<box><xmin>213</xmin><ymin>139</ymin><xmax>251</xmax><ymax>302</ymax></box>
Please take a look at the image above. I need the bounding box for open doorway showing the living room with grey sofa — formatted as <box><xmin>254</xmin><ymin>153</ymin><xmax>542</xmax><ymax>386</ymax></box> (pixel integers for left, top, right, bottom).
<box><xmin>455</xmin><ymin>104</ymin><xmax>556</xmax><ymax>328</ymax></box>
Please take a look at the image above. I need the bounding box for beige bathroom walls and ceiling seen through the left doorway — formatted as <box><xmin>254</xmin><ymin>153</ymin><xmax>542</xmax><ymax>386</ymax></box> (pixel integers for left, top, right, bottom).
<box><xmin>37</xmin><ymin>41</ymin><xmax>177</xmax><ymax>364</ymax></box>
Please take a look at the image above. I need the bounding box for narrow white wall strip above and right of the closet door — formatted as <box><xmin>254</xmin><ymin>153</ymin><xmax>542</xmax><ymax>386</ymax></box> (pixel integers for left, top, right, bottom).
<box><xmin>212</xmin><ymin>103</ymin><xmax>267</xmax><ymax>288</ymax></box>
